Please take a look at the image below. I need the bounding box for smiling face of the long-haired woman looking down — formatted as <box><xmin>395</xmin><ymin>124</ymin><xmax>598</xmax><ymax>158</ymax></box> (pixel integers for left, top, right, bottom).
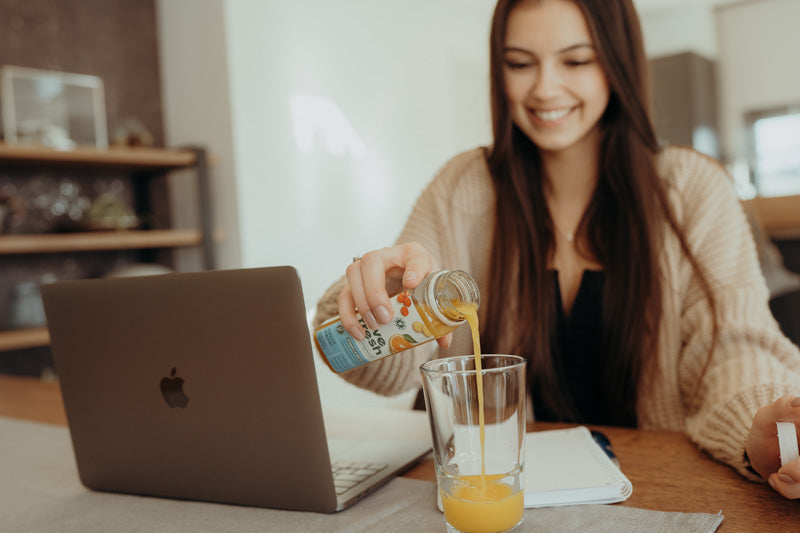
<box><xmin>503</xmin><ymin>0</ymin><xmax>610</xmax><ymax>155</ymax></box>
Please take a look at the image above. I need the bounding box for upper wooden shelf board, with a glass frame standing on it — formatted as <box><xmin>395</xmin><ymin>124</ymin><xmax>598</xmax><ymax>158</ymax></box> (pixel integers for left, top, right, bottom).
<box><xmin>0</xmin><ymin>143</ymin><xmax>195</xmax><ymax>170</ymax></box>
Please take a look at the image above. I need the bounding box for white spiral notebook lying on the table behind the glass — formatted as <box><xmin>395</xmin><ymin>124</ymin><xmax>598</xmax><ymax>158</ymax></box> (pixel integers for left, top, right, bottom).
<box><xmin>524</xmin><ymin>426</ymin><xmax>633</xmax><ymax>507</ymax></box>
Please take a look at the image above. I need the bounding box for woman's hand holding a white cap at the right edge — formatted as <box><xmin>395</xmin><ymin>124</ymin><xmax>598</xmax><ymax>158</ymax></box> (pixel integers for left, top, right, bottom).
<box><xmin>745</xmin><ymin>394</ymin><xmax>800</xmax><ymax>499</ymax></box>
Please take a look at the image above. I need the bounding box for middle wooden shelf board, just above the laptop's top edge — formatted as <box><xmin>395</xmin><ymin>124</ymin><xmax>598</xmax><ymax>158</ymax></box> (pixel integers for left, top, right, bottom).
<box><xmin>0</xmin><ymin>230</ymin><xmax>203</xmax><ymax>255</ymax></box>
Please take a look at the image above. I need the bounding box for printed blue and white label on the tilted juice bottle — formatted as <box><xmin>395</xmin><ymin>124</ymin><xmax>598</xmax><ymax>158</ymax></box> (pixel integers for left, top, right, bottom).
<box><xmin>315</xmin><ymin>291</ymin><xmax>434</xmax><ymax>373</ymax></box>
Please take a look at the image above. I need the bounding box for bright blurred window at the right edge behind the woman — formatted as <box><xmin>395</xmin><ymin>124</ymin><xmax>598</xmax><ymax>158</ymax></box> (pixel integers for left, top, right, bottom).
<box><xmin>746</xmin><ymin>107</ymin><xmax>800</xmax><ymax>196</ymax></box>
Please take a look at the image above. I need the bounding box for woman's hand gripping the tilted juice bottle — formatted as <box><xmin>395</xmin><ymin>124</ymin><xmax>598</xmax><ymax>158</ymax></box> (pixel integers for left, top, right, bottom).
<box><xmin>338</xmin><ymin>242</ymin><xmax>451</xmax><ymax>348</ymax></box>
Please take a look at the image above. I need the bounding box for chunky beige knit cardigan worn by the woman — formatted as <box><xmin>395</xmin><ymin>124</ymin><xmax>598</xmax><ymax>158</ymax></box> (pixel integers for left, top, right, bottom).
<box><xmin>315</xmin><ymin>147</ymin><xmax>800</xmax><ymax>479</ymax></box>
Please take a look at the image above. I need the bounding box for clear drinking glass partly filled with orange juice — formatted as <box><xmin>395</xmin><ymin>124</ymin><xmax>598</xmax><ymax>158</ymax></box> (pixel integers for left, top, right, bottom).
<box><xmin>420</xmin><ymin>355</ymin><xmax>525</xmax><ymax>533</ymax></box>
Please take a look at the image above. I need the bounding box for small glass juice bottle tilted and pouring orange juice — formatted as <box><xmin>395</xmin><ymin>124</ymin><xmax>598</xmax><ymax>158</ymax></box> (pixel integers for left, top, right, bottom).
<box><xmin>314</xmin><ymin>270</ymin><xmax>480</xmax><ymax>373</ymax></box>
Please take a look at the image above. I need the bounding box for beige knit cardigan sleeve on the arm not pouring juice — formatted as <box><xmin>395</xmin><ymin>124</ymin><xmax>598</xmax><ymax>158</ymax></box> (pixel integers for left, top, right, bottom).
<box><xmin>679</xmin><ymin>149</ymin><xmax>800</xmax><ymax>479</ymax></box>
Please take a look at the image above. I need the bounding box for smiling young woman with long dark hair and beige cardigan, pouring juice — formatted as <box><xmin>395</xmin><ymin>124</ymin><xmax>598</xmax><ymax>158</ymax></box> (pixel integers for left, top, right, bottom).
<box><xmin>316</xmin><ymin>0</ymin><xmax>800</xmax><ymax>498</ymax></box>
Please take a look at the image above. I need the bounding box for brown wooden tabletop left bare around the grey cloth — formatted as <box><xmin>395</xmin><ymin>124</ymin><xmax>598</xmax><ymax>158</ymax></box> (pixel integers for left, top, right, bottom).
<box><xmin>0</xmin><ymin>375</ymin><xmax>800</xmax><ymax>533</ymax></box>
